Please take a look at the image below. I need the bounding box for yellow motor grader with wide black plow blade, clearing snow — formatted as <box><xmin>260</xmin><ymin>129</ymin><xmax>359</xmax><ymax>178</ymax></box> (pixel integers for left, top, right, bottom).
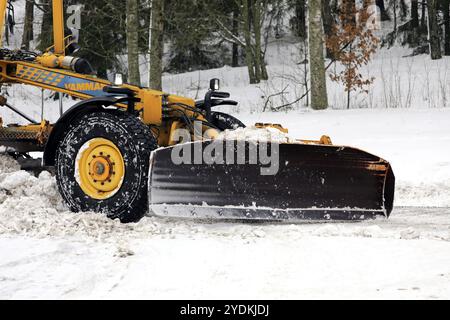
<box><xmin>0</xmin><ymin>0</ymin><xmax>395</xmax><ymax>222</ymax></box>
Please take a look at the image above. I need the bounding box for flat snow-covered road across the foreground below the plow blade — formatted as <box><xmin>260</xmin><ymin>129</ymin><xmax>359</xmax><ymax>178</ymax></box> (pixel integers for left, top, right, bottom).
<box><xmin>0</xmin><ymin>208</ymin><xmax>450</xmax><ymax>299</ymax></box>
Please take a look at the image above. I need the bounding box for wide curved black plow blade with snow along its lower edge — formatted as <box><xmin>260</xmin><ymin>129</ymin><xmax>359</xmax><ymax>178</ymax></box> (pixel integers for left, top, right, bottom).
<box><xmin>149</xmin><ymin>141</ymin><xmax>395</xmax><ymax>221</ymax></box>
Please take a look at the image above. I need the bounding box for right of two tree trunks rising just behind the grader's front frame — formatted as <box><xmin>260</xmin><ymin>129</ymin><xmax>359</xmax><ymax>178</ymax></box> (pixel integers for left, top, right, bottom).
<box><xmin>149</xmin><ymin>0</ymin><xmax>164</xmax><ymax>91</ymax></box>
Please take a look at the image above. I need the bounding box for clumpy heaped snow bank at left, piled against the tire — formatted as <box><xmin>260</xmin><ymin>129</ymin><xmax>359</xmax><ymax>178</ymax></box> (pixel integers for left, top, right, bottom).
<box><xmin>0</xmin><ymin>155</ymin><xmax>202</xmax><ymax>242</ymax></box>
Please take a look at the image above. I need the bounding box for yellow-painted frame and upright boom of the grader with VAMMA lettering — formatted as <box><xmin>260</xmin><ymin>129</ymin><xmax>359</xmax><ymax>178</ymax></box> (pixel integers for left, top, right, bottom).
<box><xmin>0</xmin><ymin>0</ymin><xmax>209</xmax><ymax>146</ymax></box>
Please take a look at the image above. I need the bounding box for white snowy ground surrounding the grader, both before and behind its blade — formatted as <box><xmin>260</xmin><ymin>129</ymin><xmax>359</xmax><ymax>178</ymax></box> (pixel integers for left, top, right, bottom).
<box><xmin>0</xmin><ymin>109</ymin><xmax>450</xmax><ymax>299</ymax></box>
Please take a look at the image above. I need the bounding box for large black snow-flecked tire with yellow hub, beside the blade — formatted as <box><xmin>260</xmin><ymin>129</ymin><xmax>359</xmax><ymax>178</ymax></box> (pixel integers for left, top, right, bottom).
<box><xmin>56</xmin><ymin>110</ymin><xmax>158</xmax><ymax>223</ymax></box>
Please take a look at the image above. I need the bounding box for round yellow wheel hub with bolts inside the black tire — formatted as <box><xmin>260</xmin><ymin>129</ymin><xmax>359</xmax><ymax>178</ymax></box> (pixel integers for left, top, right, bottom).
<box><xmin>77</xmin><ymin>138</ymin><xmax>125</xmax><ymax>200</ymax></box>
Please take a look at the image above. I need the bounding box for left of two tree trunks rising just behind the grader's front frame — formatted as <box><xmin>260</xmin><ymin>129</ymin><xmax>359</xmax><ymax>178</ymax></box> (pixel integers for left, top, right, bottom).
<box><xmin>127</xmin><ymin>0</ymin><xmax>141</xmax><ymax>86</ymax></box>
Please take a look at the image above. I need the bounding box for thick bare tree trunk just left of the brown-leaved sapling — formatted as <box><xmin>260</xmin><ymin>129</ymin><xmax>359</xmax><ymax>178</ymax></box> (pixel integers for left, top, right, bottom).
<box><xmin>309</xmin><ymin>0</ymin><xmax>328</xmax><ymax>110</ymax></box>
